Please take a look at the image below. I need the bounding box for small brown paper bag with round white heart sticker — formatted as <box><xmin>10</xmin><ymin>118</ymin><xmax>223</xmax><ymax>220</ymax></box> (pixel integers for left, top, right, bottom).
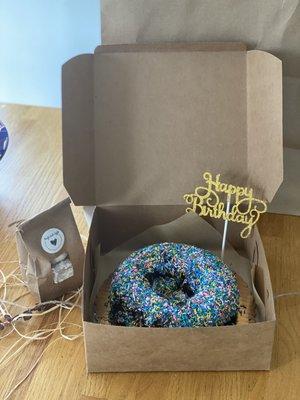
<box><xmin>16</xmin><ymin>199</ymin><xmax>84</xmax><ymax>302</ymax></box>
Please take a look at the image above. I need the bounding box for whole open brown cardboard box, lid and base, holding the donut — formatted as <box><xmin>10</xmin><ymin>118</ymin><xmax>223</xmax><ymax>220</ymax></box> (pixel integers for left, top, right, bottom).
<box><xmin>62</xmin><ymin>43</ymin><xmax>283</xmax><ymax>372</ymax></box>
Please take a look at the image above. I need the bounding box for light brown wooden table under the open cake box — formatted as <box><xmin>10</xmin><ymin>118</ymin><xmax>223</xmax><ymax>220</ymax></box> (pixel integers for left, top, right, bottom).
<box><xmin>0</xmin><ymin>105</ymin><xmax>300</xmax><ymax>400</ymax></box>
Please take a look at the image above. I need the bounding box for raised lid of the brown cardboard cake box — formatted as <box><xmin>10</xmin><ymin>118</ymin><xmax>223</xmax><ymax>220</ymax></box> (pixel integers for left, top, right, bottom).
<box><xmin>62</xmin><ymin>43</ymin><xmax>283</xmax><ymax>205</ymax></box>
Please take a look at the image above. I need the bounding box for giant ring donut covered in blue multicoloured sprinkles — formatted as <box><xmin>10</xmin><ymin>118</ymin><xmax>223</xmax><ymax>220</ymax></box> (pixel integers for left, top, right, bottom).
<box><xmin>108</xmin><ymin>243</ymin><xmax>239</xmax><ymax>327</ymax></box>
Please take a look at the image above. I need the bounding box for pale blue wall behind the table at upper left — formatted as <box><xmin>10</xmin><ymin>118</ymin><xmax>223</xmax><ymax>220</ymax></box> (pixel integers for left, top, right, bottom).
<box><xmin>0</xmin><ymin>0</ymin><xmax>100</xmax><ymax>107</ymax></box>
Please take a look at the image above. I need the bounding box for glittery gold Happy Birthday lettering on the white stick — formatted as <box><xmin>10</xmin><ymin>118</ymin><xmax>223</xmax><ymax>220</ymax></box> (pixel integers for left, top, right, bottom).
<box><xmin>183</xmin><ymin>172</ymin><xmax>267</xmax><ymax>239</ymax></box>
